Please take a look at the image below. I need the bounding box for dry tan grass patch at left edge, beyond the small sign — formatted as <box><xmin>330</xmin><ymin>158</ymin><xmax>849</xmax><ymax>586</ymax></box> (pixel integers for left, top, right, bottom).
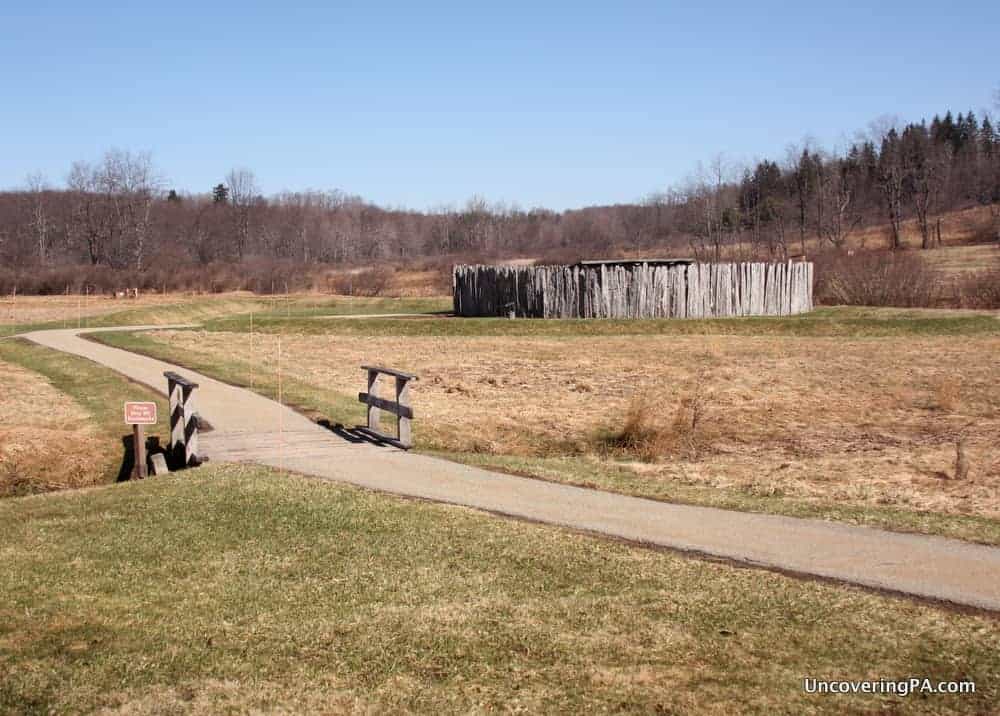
<box><xmin>0</xmin><ymin>362</ymin><xmax>95</xmax><ymax>496</ymax></box>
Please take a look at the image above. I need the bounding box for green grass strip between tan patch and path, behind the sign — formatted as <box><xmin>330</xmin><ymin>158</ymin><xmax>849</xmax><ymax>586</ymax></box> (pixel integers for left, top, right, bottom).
<box><xmin>0</xmin><ymin>339</ymin><xmax>169</xmax><ymax>482</ymax></box>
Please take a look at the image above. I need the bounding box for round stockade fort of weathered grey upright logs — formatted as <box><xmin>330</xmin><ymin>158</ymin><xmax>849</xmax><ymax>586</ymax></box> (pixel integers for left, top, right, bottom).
<box><xmin>452</xmin><ymin>259</ymin><xmax>813</xmax><ymax>318</ymax></box>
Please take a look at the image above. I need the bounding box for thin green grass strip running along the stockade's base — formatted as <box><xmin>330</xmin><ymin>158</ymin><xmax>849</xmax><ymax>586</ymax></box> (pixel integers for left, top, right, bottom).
<box><xmin>204</xmin><ymin>306</ymin><xmax>1000</xmax><ymax>338</ymax></box>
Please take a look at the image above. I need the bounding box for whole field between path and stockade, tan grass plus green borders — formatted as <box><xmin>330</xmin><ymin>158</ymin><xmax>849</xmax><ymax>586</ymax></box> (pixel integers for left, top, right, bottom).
<box><xmin>95</xmin><ymin>308</ymin><xmax>1000</xmax><ymax>544</ymax></box>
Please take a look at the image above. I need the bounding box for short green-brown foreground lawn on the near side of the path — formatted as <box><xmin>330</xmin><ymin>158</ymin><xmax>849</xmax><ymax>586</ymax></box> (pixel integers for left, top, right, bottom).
<box><xmin>0</xmin><ymin>465</ymin><xmax>1000</xmax><ymax>714</ymax></box>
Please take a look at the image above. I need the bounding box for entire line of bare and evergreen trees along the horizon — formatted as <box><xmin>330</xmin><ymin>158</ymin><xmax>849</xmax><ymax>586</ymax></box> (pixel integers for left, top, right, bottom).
<box><xmin>0</xmin><ymin>105</ymin><xmax>1000</xmax><ymax>292</ymax></box>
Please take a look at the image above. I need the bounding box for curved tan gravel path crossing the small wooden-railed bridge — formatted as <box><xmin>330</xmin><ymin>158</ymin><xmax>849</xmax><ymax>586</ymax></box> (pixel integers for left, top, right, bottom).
<box><xmin>24</xmin><ymin>326</ymin><xmax>1000</xmax><ymax>611</ymax></box>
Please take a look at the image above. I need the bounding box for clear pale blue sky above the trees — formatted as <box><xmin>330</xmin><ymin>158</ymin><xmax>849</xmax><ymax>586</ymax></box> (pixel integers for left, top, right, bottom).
<box><xmin>0</xmin><ymin>0</ymin><xmax>1000</xmax><ymax>209</ymax></box>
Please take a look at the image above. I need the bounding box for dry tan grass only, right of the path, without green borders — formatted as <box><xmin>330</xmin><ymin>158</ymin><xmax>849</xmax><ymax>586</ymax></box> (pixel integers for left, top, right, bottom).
<box><xmin>148</xmin><ymin>331</ymin><xmax>1000</xmax><ymax>517</ymax></box>
